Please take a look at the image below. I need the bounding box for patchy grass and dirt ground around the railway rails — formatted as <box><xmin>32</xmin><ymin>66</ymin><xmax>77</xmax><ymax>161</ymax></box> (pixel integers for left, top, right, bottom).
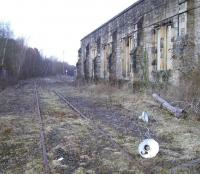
<box><xmin>0</xmin><ymin>77</ymin><xmax>200</xmax><ymax>174</ymax></box>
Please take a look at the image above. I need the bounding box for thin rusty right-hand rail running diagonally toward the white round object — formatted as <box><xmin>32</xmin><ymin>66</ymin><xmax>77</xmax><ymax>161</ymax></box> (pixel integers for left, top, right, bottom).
<box><xmin>53</xmin><ymin>90</ymin><xmax>148</xmax><ymax>173</ymax></box>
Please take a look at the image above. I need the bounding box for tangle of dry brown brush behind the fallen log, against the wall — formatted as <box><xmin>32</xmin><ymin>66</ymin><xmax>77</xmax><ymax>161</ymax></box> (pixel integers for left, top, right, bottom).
<box><xmin>162</xmin><ymin>69</ymin><xmax>200</xmax><ymax>120</ymax></box>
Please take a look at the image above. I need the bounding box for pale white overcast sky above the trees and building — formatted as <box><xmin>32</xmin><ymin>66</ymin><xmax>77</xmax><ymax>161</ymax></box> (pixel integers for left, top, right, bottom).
<box><xmin>0</xmin><ymin>0</ymin><xmax>137</xmax><ymax>65</ymax></box>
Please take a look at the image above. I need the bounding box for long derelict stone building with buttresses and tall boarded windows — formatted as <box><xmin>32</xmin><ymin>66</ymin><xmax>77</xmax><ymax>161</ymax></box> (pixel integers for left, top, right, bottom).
<box><xmin>77</xmin><ymin>0</ymin><xmax>200</xmax><ymax>85</ymax></box>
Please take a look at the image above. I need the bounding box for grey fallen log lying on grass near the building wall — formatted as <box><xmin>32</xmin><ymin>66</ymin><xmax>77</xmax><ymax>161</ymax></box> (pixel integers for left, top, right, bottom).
<box><xmin>152</xmin><ymin>94</ymin><xmax>185</xmax><ymax>118</ymax></box>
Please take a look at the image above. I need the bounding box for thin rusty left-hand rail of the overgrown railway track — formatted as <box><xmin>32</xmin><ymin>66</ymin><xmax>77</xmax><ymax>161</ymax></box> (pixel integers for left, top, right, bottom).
<box><xmin>34</xmin><ymin>82</ymin><xmax>50</xmax><ymax>174</ymax></box>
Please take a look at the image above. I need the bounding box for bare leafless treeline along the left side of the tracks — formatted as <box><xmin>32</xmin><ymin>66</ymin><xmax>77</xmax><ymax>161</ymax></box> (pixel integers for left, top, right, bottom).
<box><xmin>0</xmin><ymin>23</ymin><xmax>75</xmax><ymax>81</ymax></box>
